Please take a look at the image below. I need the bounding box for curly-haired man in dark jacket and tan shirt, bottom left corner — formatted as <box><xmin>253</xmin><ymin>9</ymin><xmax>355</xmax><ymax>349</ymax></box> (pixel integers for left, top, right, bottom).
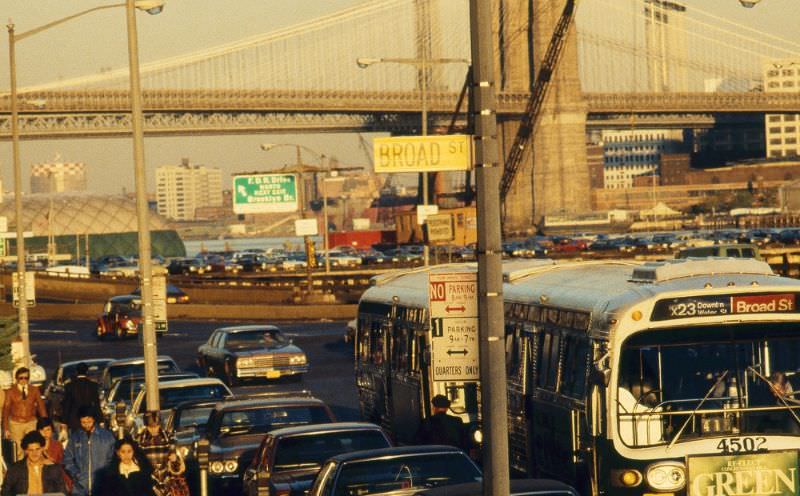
<box><xmin>0</xmin><ymin>431</ymin><xmax>67</xmax><ymax>496</ymax></box>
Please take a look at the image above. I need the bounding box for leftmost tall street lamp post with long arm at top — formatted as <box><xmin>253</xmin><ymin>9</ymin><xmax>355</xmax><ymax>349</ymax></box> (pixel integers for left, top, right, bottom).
<box><xmin>6</xmin><ymin>0</ymin><xmax>166</xmax><ymax>368</ymax></box>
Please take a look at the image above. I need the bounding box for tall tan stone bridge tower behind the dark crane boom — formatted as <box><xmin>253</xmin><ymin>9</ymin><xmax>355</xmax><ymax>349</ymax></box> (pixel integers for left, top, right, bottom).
<box><xmin>493</xmin><ymin>0</ymin><xmax>591</xmax><ymax>232</ymax></box>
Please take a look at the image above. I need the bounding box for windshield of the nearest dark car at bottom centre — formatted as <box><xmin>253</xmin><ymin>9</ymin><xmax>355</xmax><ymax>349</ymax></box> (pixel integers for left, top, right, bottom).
<box><xmin>333</xmin><ymin>453</ymin><xmax>481</xmax><ymax>496</ymax></box>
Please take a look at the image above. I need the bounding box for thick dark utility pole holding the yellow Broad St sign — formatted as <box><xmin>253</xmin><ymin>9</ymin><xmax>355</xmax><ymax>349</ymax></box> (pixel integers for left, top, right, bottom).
<box><xmin>469</xmin><ymin>0</ymin><xmax>509</xmax><ymax>496</ymax></box>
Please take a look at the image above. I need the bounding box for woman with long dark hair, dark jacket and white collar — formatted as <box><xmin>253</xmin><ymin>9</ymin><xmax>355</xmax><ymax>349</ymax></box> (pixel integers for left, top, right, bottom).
<box><xmin>96</xmin><ymin>437</ymin><xmax>156</xmax><ymax>496</ymax></box>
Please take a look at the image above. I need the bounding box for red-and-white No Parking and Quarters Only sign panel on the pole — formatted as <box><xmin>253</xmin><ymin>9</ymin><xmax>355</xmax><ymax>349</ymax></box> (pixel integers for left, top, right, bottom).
<box><xmin>428</xmin><ymin>272</ymin><xmax>480</xmax><ymax>381</ymax></box>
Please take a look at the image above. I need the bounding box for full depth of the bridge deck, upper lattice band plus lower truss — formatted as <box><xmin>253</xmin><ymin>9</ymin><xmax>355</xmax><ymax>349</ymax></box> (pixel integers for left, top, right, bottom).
<box><xmin>0</xmin><ymin>90</ymin><xmax>800</xmax><ymax>140</ymax></box>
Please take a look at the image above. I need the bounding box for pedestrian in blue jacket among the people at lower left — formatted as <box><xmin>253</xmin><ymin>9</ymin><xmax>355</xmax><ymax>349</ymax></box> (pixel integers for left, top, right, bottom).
<box><xmin>64</xmin><ymin>406</ymin><xmax>114</xmax><ymax>496</ymax></box>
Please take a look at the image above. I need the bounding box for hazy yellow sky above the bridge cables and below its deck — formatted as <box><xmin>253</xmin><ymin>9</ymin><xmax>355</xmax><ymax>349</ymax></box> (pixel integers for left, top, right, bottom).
<box><xmin>0</xmin><ymin>0</ymin><xmax>800</xmax><ymax>193</ymax></box>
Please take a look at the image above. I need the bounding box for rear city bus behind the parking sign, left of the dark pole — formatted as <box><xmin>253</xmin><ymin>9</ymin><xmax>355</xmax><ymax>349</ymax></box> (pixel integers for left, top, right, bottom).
<box><xmin>354</xmin><ymin>264</ymin><xmax>480</xmax><ymax>444</ymax></box>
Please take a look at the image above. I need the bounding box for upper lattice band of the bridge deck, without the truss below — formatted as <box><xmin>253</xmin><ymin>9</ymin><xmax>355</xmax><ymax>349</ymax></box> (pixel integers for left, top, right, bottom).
<box><xmin>0</xmin><ymin>90</ymin><xmax>800</xmax><ymax>115</ymax></box>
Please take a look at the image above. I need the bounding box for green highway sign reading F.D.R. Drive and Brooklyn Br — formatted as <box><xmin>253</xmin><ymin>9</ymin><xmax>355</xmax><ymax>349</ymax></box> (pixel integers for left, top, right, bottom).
<box><xmin>233</xmin><ymin>174</ymin><xmax>297</xmax><ymax>214</ymax></box>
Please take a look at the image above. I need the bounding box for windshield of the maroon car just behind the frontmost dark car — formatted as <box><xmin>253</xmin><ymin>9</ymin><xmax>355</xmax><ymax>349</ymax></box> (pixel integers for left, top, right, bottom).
<box><xmin>274</xmin><ymin>430</ymin><xmax>389</xmax><ymax>470</ymax></box>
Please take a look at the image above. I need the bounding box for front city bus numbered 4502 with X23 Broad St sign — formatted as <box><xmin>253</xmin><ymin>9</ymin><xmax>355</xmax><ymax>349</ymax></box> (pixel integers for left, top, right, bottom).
<box><xmin>503</xmin><ymin>258</ymin><xmax>800</xmax><ymax>496</ymax></box>
